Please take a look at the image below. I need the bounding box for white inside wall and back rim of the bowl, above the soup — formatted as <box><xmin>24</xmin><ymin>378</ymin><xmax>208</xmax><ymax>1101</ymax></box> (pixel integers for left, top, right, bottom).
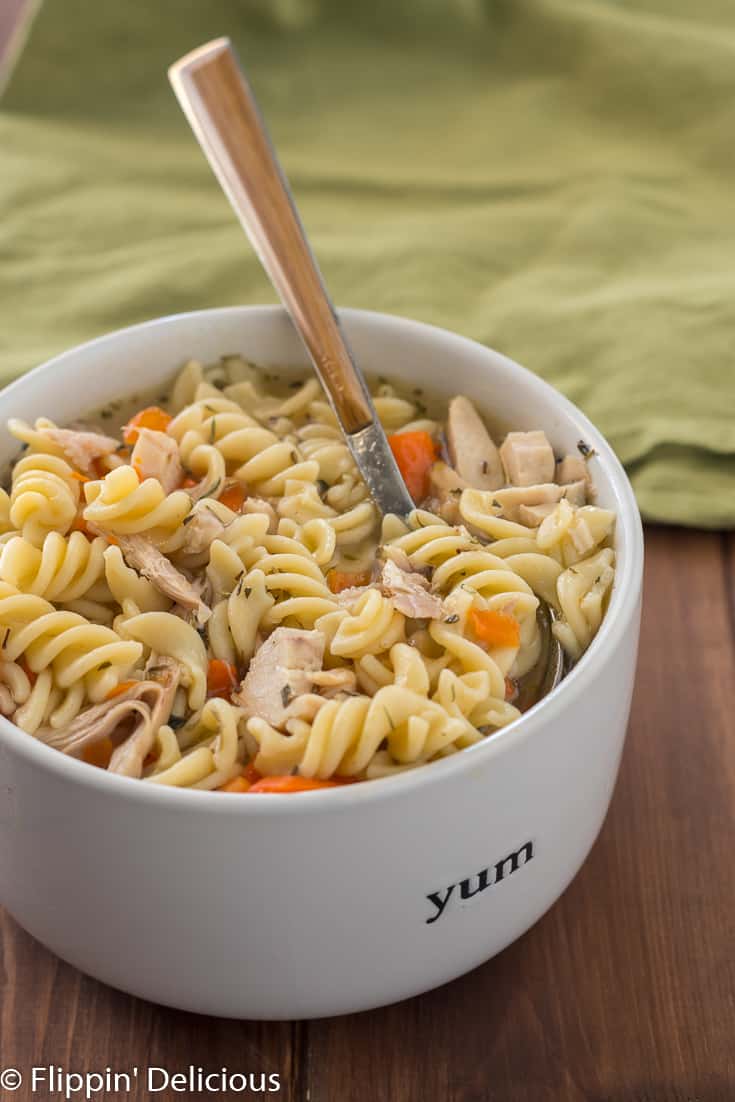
<box><xmin>0</xmin><ymin>306</ymin><xmax>642</xmax><ymax>802</ymax></box>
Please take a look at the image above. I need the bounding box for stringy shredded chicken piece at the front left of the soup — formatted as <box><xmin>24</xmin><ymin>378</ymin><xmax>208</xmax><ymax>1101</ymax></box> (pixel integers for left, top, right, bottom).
<box><xmin>36</xmin><ymin>656</ymin><xmax>180</xmax><ymax>777</ymax></box>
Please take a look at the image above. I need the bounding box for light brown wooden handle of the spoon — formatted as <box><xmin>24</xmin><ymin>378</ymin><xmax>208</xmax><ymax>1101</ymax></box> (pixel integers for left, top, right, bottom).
<box><xmin>169</xmin><ymin>39</ymin><xmax>374</xmax><ymax>433</ymax></box>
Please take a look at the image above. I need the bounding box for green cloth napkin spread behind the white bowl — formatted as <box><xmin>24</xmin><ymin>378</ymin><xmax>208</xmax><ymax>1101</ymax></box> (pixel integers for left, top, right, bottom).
<box><xmin>0</xmin><ymin>0</ymin><xmax>735</xmax><ymax>527</ymax></box>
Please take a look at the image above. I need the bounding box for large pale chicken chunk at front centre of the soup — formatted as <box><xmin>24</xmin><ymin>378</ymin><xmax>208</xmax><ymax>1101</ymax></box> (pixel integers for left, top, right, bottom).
<box><xmin>233</xmin><ymin>627</ymin><xmax>326</xmax><ymax>727</ymax></box>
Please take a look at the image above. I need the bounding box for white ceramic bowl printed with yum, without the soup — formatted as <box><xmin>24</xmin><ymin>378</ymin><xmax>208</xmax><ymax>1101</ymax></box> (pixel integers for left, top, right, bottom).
<box><xmin>0</xmin><ymin>306</ymin><xmax>642</xmax><ymax>1018</ymax></box>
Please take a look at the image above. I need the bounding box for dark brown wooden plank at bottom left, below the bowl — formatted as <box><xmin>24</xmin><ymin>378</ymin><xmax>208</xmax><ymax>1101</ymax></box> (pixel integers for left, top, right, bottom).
<box><xmin>0</xmin><ymin>911</ymin><xmax>303</xmax><ymax>1102</ymax></box>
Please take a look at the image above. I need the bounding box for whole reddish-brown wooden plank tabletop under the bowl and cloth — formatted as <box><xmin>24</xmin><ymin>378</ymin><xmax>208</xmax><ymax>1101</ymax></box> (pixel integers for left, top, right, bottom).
<box><xmin>0</xmin><ymin>0</ymin><xmax>735</xmax><ymax>1102</ymax></box>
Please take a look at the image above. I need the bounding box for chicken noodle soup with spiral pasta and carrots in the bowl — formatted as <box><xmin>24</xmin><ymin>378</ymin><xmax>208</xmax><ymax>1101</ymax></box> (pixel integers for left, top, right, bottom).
<box><xmin>0</xmin><ymin>357</ymin><xmax>615</xmax><ymax>793</ymax></box>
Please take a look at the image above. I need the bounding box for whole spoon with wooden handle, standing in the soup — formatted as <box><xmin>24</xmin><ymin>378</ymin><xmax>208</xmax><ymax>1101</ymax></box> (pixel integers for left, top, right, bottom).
<box><xmin>169</xmin><ymin>45</ymin><xmax>563</xmax><ymax>706</ymax></box>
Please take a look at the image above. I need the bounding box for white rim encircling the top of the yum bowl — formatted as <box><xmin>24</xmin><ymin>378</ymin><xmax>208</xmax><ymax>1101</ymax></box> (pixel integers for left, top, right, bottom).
<box><xmin>0</xmin><ymin>306</ymin><xmax>644</xmax><ymax>815</ymax></box>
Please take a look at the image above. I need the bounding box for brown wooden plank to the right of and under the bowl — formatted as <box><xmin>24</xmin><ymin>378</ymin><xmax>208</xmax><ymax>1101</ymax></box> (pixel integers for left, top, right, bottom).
<box><xmin>310</xmin><ymin>530</ymin><xmax>735</xmax><ymax>1102</ymax></box>
